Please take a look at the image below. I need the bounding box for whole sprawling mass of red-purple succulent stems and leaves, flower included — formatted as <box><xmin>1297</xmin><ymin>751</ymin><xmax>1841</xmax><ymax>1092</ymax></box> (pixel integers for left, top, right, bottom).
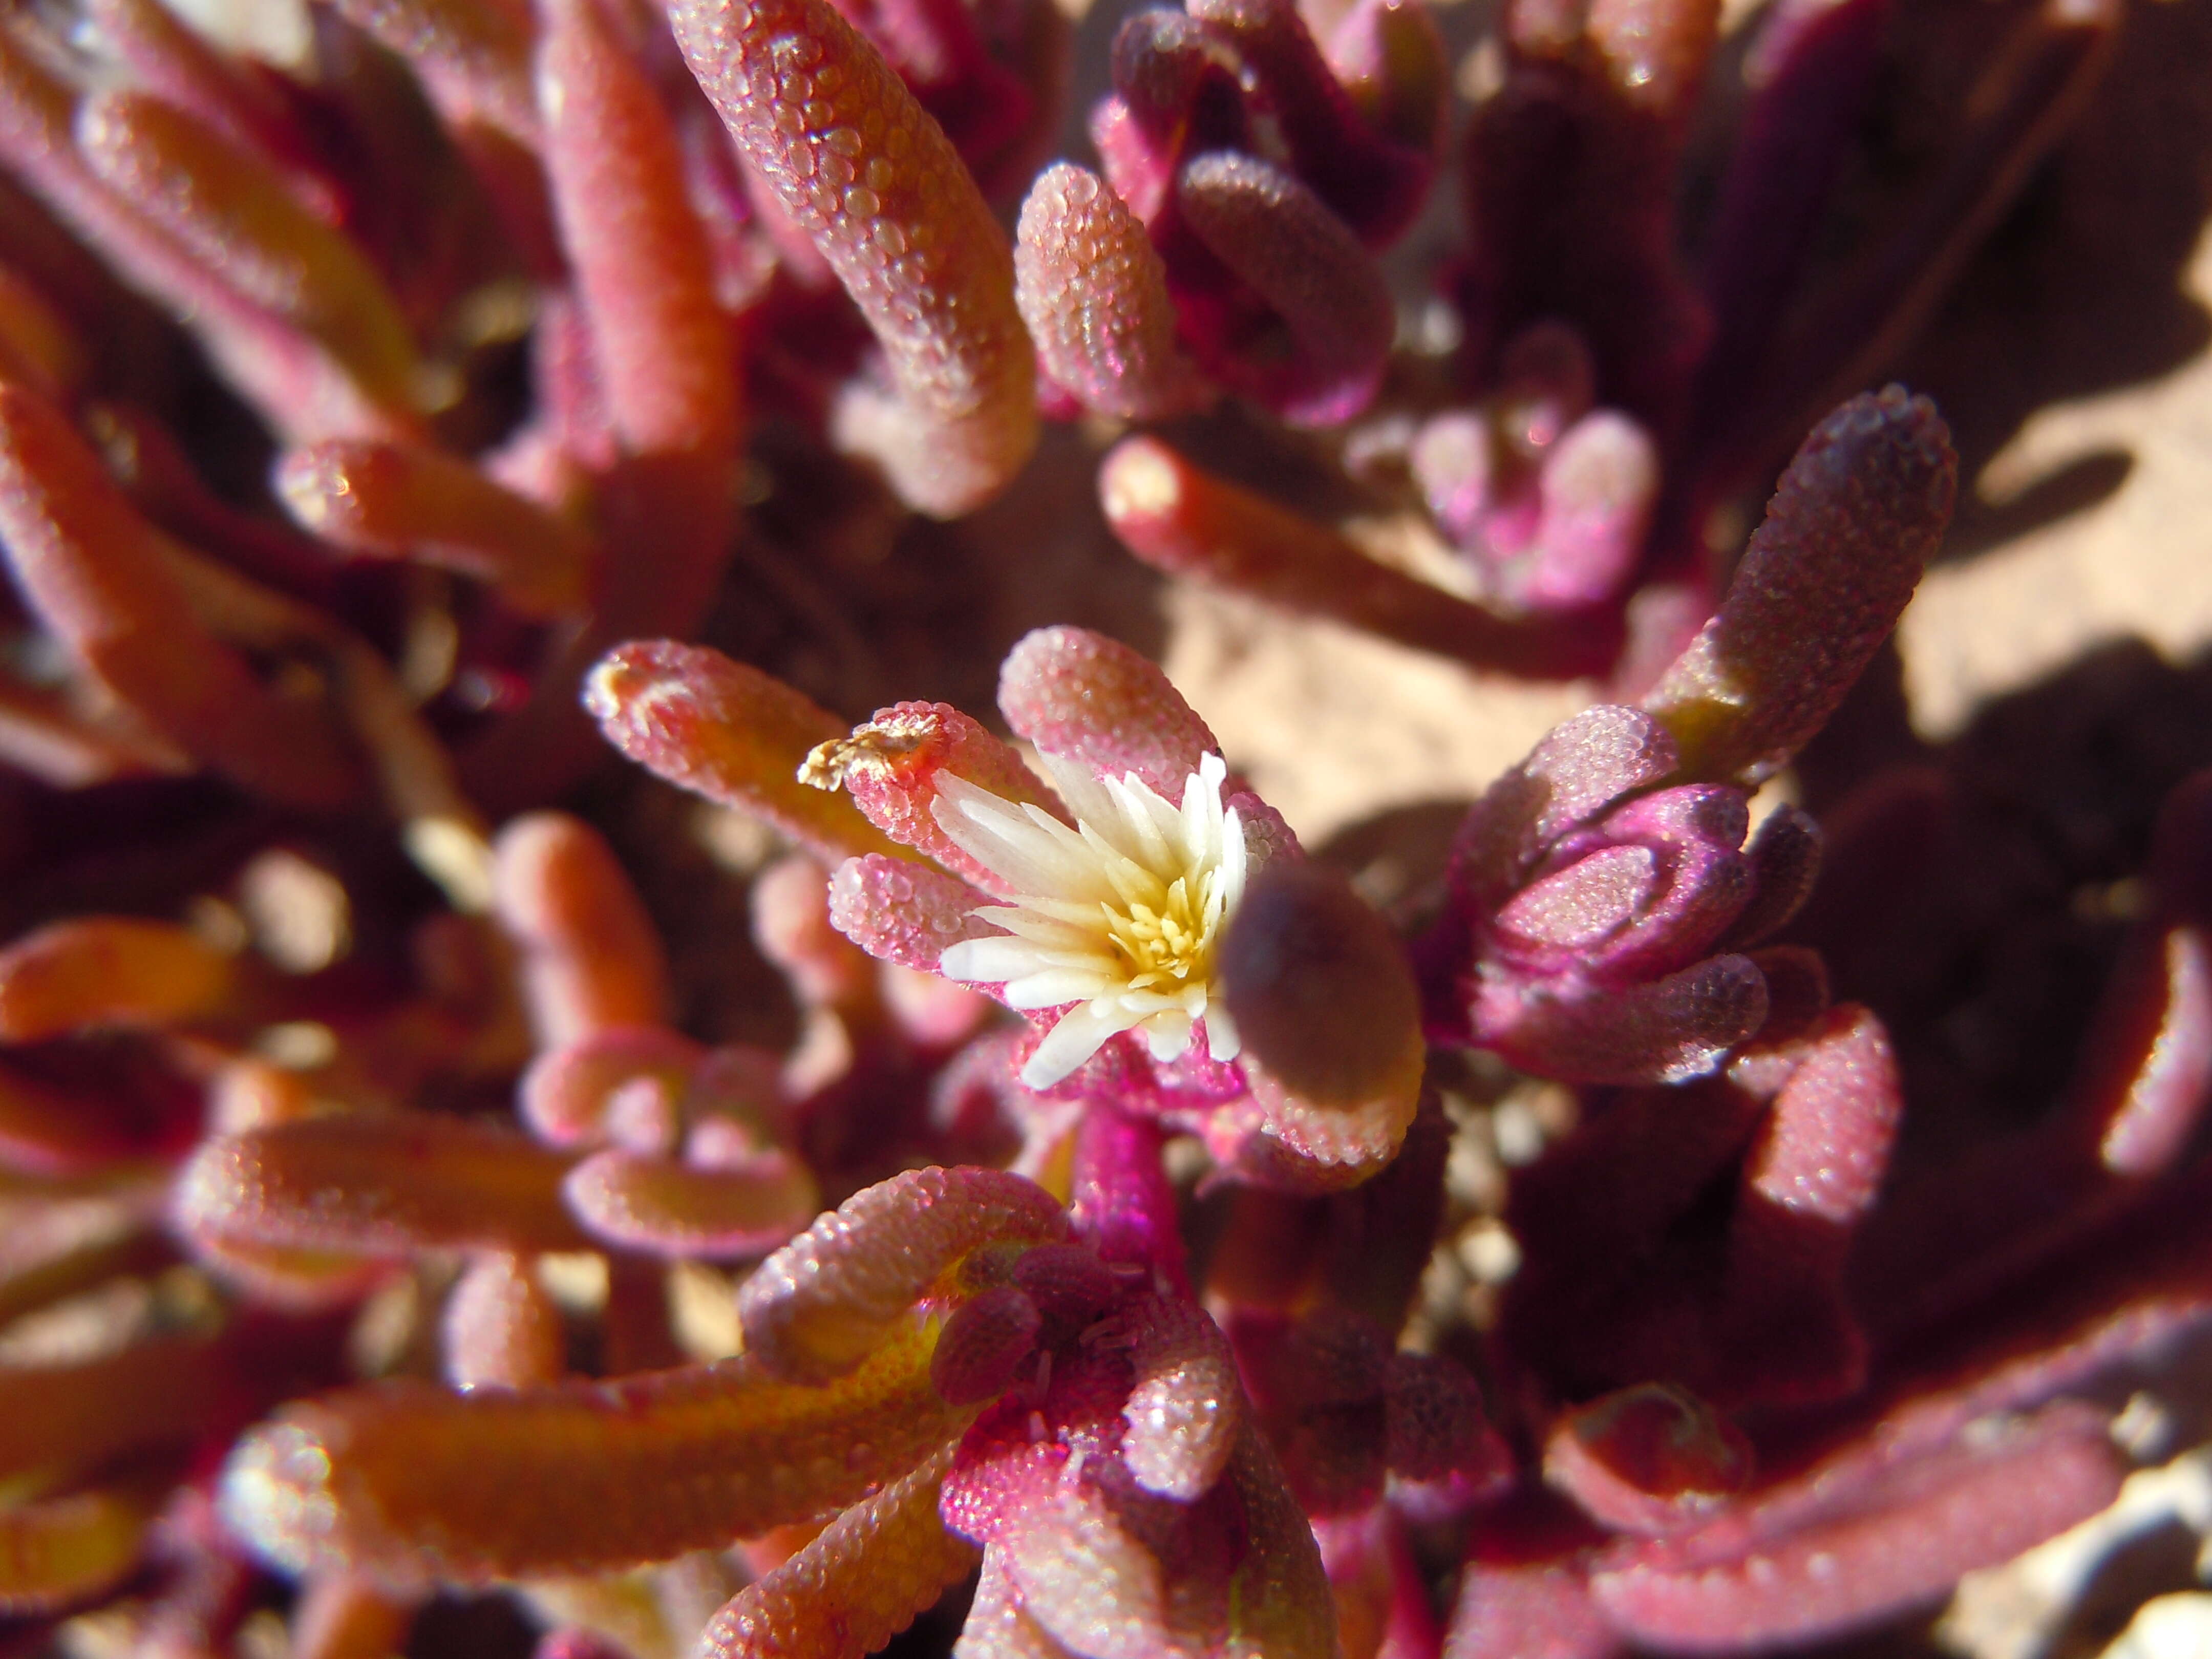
<box><xmin>0</xmin><ymin>0</ymin><xmax>2212</xmax><ymax>1659</ymax></box>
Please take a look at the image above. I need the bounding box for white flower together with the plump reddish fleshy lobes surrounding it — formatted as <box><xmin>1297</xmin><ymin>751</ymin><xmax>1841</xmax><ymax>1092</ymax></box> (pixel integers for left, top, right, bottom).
<box><xmin>801</xmin><ymin>628</ymin><xmax>1422</xmax><ymax>1188</ymax></box>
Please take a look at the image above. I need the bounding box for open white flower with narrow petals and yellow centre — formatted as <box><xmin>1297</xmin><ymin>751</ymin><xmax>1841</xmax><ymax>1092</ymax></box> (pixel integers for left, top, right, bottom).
<box><xmin>929</xmin><ymin>754</ymin><xmax>1245</xmax><ymax>1088</ymax></box>
